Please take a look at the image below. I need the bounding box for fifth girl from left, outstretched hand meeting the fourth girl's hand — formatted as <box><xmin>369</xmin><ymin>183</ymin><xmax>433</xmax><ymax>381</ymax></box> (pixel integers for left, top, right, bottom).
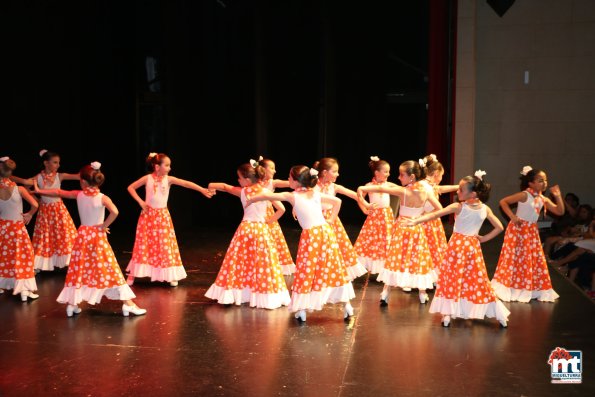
<box><xmin>205</xmin><ymin>160</ymin><xmax>291</xmax><ymax>309</ymax></box>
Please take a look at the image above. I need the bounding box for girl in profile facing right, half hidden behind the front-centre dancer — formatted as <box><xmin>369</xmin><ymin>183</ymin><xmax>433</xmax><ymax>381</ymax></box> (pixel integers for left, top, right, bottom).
<box><xmin>312</xmin><ymin>157</ymin><xmax>370</xmax><ymax>280</ymax></box>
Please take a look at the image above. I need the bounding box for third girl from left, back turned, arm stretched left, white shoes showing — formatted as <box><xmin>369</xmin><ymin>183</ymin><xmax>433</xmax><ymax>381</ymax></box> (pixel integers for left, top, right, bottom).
<box><xmin>35</xmin><ymin>161</ymin><xmax>147</xmax><ymax>317</ymax></box>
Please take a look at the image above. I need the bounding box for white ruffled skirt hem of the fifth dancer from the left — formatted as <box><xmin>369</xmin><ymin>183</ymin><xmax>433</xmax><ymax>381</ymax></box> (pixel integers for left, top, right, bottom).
<box><xmin>205</xmin><ymin>284</ymin><xmax>291</xmax><ymax>309</ymax></box>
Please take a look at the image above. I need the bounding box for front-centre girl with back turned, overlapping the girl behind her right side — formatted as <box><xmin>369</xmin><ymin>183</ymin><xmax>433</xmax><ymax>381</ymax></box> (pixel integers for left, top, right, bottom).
<box><xmin>249</xmin><ymin>165</ymin><xmax>355</xmax><ymax>322</ymax></box>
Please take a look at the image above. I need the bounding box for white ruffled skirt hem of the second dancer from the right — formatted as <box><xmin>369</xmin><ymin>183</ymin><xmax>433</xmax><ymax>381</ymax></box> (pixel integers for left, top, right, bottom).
<box><xmin>430</xmin><ymin>296</ymin><xmax>510</xmax><ymax>321</ymax></box>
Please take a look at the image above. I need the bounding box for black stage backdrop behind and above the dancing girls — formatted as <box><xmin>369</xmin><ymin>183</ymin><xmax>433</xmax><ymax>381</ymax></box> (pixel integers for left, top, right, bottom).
<box><xmin>0</xmin><ymin>0</ymin><xmax>454</xmax><ymax>241</ymax></box>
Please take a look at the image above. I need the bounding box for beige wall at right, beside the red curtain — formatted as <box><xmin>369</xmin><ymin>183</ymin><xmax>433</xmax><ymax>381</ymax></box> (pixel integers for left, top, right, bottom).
<box><xmin>455</xmin><ymin>0</ymin><xmax>595</xmax><ymax>213</ymax></box>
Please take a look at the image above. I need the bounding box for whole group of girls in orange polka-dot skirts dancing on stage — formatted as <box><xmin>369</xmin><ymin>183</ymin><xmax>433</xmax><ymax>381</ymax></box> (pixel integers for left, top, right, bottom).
<box><xmin>0</xmin><ymin>150</ymin><xmax>564</xmax><ymax>327</ymax></box>
